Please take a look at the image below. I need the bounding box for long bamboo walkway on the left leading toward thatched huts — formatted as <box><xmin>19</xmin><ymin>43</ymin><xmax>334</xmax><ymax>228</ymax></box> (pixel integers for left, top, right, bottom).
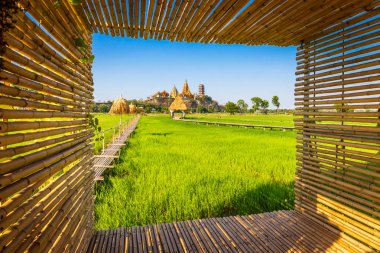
<box><xmin>93</xmin><ymin>116</ymin><xmax>140</xmax><ymax>181</ymax></box>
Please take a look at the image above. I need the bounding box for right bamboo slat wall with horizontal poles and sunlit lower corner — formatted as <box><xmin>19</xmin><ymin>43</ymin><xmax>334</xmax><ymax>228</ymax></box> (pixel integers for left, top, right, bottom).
<box><xmin>295</xmin><ymin>8</ymin><xmax>380</xmax><ymax>251</ymax></box>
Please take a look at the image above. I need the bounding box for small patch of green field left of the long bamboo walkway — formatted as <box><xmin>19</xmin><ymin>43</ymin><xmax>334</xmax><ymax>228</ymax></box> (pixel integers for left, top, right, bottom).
<box><xmin>94</xmin><ymin>113</ymin><xmax>132</xmax><ymax>153</ymax></box>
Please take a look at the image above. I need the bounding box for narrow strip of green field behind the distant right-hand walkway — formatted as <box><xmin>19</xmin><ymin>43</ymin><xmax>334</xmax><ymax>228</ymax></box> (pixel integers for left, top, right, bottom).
<box><xmin>186</xmin><ymin>113</ymin><xmax>294</xmax><ymax>126</ymax></box>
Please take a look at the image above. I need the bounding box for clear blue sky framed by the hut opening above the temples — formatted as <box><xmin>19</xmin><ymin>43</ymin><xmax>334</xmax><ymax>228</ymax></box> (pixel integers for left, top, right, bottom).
<box><xmin>93</xmin><ymin>34</ymin><xmax>296</xmax><ymax>108</ymax></box>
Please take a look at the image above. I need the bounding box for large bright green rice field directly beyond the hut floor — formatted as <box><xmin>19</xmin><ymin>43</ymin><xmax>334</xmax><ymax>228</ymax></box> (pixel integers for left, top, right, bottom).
<box><xmin>95</xmin><ymin>116</ymin><xmax>295</xmax><ymax>229</ymax></box>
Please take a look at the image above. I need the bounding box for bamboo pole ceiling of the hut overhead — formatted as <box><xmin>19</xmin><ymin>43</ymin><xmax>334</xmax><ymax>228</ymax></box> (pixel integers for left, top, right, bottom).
<box><xmin>78</xmin><ymin>0</ymin><xmax>378</xmax><ymax>46</ymax></box>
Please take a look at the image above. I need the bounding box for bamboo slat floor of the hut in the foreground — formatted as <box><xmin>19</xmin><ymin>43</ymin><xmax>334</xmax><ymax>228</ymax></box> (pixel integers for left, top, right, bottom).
<box><xmin>87</xmin><ymin>211</ymin><xmax>363</xmax><ymax>252</ymax></box>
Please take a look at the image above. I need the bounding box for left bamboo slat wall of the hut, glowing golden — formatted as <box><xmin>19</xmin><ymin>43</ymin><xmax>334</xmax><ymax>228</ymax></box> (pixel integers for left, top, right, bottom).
<box><xmin>0</xmin><ymin>0</ymin><xmax>94</xmax><ymax>252</ymax></box>
